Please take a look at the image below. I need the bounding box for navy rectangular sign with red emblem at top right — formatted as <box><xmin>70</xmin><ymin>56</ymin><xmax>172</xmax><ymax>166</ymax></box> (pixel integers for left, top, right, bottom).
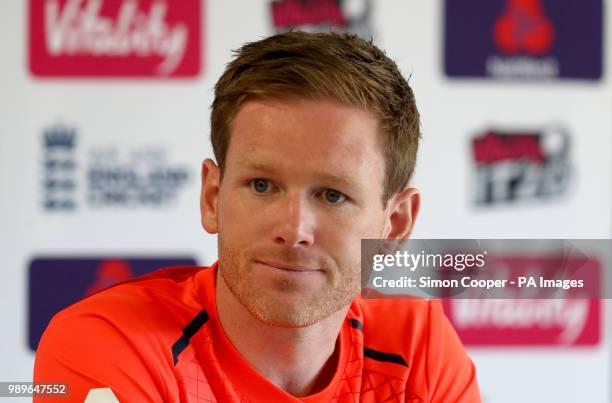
<box><xmin>444</xmin><ymin>0</ymin><xmax>603</xmax><ymax>80</ymax></box>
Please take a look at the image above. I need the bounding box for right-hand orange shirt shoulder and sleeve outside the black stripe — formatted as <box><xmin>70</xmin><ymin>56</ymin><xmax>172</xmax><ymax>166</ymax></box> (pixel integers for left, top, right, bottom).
<box><xmin>351</xmin><ymin>296</ymin><xmax>480</xmax><ymax>403</ymax></box>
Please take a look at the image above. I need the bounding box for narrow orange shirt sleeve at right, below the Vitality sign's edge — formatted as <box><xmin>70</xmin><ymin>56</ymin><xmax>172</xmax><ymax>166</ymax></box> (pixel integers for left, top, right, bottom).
<box><xmin>426</xmin><ymin>301</ymin><xmax>482</xmax><ymax>403</ymax></box>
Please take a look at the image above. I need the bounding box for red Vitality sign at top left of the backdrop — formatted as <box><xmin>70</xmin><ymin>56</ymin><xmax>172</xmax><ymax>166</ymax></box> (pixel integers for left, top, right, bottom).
<box><xmin>29</xmin><ymin>0</ymin><xmax>201</xmax><ymax>78</ymax></box>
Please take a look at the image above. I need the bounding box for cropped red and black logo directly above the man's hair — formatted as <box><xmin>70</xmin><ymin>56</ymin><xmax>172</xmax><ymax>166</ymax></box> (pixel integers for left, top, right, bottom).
<box><xmin>270</xmin><ymin>0</ymin><xmax>374</xmax><ymax>39</ymax></box>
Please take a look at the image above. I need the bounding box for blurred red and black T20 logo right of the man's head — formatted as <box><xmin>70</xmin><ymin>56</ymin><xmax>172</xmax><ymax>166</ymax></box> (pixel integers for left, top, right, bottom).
<box><xmin>472</xmin><ymin>129</ymin><xmax>571</xmax><ymax>205</ymax></box>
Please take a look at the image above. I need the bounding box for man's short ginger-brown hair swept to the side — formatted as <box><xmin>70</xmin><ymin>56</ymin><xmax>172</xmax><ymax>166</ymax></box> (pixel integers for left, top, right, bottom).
<box><xmin>210</xmin><ymin>31</ymin><xmax>420</xmax><ymax>206</ymax></box>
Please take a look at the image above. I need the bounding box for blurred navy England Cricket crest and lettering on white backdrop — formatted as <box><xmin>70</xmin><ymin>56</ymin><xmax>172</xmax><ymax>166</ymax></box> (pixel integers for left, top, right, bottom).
<box><xmin>41</xmin><ymin>124</ymin><xmax>191</xmax><ymax>211</ymax></box>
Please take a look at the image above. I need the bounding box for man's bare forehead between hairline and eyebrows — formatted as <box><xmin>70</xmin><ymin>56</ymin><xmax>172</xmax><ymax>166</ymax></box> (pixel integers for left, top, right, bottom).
<box><xmin>226</xmin><ymin>100</ymin><xmax>384</xmax><ymax>179</ymax></box>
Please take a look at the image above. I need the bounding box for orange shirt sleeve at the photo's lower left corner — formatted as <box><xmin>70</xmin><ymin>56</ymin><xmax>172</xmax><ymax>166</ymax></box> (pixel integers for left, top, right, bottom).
<box><xmin>34</xmin><ymin>313</ymin><xmax>174</xmax><ymax>403</ymax></box>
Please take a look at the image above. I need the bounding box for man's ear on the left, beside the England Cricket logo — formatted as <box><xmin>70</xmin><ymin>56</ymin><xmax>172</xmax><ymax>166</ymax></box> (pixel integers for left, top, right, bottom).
<box><xmin>200</xmin><ymin>159</ymin><xmax>221</xmax><ymax>234</ymax></box>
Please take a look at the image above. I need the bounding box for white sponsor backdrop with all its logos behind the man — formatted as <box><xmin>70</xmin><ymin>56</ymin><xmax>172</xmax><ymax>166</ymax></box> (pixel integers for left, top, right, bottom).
<box><xmin>0</xmin><ymin>0</ymin><xmax>612</xmax><ymax>403</ymax></box>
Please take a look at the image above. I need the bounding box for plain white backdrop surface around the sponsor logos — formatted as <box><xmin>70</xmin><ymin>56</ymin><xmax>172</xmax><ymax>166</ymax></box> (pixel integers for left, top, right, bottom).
<box><xmin>0</xmin><ymin>0</ymin><xmax>612</xmax><ymax>403</ymax></box>
